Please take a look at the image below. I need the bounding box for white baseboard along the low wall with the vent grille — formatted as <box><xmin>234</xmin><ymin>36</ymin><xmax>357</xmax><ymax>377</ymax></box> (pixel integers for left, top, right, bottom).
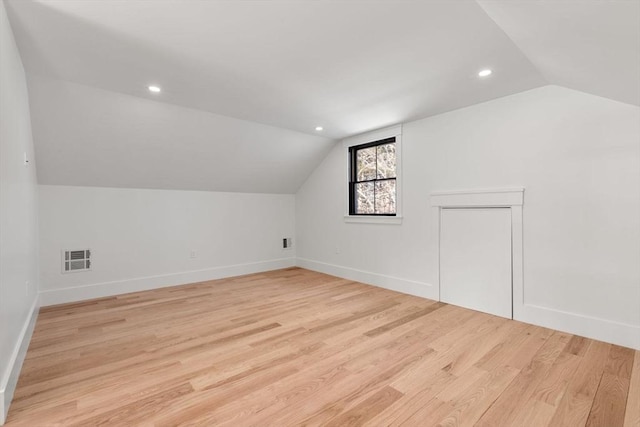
<box><xmin>40</xmin><ymin>257</ymin><xmax>296</xmax><ymax>307</ymax></box>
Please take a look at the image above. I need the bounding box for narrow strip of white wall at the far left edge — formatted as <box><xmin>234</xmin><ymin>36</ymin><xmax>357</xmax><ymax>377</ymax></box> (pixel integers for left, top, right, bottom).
<box><xmin>0</xmin><ymin>2</ymin><xmax>38</xmax><ymax>424</ymax></box>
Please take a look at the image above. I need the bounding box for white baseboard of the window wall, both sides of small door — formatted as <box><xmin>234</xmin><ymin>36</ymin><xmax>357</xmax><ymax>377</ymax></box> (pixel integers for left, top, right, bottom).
<box><xmin>296</xmin><ymin>258</ymin><xmax>640</xmax><ymax>350</ymax></box>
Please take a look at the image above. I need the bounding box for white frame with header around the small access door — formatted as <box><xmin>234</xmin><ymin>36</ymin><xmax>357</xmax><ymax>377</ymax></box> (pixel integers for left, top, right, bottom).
<box><xmin>430</xmin><ymin>187</ymin><xmax>524</xmax><ymax>319</ymax></box>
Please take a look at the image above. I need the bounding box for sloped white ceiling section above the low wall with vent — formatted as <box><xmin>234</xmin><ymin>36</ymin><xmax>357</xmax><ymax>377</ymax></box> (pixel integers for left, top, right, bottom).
<box><xmin>24</xmin><ymin>76</ymin><xmax>334</xmax><ymax>194</ymax></box>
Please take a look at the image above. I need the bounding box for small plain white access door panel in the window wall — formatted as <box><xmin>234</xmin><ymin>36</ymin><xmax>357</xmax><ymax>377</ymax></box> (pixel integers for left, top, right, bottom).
<box><xmin>440</xmin><ymin>208</ymin><xmax>513</xmax><ymax>319</ymax></box>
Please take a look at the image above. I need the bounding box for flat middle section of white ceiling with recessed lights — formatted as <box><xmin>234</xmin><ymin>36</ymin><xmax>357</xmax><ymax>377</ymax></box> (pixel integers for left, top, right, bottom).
<box><xmin>9</xmin><ymin>0</ymin><xmax>545</xmax><ymax>138</ymax></box>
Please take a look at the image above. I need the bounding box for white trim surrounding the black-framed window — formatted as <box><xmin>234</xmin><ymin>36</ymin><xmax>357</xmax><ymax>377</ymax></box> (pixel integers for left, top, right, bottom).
<box><xmin>342</xmin><ymin>124</ymin><xmax>402</xmax><ymax>224</ymax></box>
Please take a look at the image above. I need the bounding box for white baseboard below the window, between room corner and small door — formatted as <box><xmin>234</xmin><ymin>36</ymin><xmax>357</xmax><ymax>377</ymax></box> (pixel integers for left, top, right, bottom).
<box><xmin>296</xmin><ymin>258</ymin><xmax>439</xmax><ymax>301</ymax></box>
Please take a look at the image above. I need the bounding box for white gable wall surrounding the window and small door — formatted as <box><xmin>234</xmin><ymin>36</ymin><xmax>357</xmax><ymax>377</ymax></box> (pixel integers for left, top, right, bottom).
<box><xmin>296</xmin><ymin>86</ymin><xmax>640</xmax><ymax>348</ymax></box>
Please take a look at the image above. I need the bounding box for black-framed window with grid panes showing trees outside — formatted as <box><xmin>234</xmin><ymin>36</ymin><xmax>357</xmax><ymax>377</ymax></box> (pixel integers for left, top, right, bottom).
<box><xmin>349</xmin><ymin>137</ymin><xmax>397</xmax><ymax>216</ymax></box>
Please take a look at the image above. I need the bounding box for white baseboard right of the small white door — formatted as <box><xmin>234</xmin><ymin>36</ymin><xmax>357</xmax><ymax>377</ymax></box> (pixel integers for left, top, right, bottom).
<box><xmin>515</xmin><ymin>304</ymin><xmax>640</xmax><ymax>350</ymax></box>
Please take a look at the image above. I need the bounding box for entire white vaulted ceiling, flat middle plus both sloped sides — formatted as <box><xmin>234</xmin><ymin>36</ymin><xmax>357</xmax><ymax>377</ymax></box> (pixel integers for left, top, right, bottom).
<box><xmin>6</xmin><ymin>0</ymin><xmax>640</xmax><ymax>192</ymax></box>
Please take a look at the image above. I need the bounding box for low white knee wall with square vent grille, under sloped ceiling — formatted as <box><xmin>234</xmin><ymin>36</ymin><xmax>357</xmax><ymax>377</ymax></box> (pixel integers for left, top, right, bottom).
<box><xmin>40</xmin><ymin>185</ymin><xmax>295</xmax><ymax>305</ymax></box>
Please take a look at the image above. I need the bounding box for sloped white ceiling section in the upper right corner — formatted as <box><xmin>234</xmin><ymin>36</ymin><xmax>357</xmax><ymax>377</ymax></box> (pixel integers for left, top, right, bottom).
<box><xmin>478</xmin><ymin>0</ymin><xmax>640</xmax><ymax>105</ymax></box>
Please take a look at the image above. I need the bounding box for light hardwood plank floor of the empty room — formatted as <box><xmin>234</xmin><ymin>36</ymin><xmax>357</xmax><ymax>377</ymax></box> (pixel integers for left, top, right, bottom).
<box><xmin>7</xmin><ymin>268</ymin><xmax>640</xmax><ymax>427</ymax></box>
